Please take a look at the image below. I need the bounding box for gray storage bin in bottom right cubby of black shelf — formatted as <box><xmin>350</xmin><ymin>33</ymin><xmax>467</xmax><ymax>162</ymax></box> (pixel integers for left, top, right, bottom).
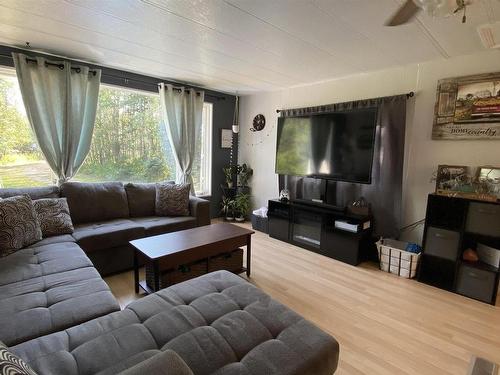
<box><xmin>457</xmin><ymin>264</ymin><xmax>496</xmax><ymax>303</ymax></box>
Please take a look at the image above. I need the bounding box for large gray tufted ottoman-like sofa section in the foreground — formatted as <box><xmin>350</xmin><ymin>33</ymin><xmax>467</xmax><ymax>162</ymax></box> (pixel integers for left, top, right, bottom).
<box><xmin>11</xmin><ymin>271</ymin><xmax>338</xmax><ymax>375</ymax></box>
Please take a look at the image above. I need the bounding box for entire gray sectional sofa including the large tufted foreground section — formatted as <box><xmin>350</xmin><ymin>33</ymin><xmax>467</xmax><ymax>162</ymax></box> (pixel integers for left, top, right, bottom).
<box><xmin>0</xmin><ymin>183</ymin><xmax>339</xmax><ymax>375</ymax></box>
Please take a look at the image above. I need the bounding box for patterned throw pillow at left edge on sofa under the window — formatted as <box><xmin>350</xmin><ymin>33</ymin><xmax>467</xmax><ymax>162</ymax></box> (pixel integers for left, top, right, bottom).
<box><xmin>0</xmin><ymin>195</ymin><xmax>42</xmax><ymax>257</ymax></box>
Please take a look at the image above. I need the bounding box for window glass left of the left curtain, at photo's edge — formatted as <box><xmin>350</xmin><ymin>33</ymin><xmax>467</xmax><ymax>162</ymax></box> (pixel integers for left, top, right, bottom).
<box><xmin>0</xmin><ymin>67</ymin><xmax>55</xmax><ymax>188</ymax></box>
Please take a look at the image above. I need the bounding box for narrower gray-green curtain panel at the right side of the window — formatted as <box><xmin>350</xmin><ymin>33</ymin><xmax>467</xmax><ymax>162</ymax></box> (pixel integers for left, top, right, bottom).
<box><xmin>159</xmin><ymin>83</ymin><xmax>205</xmax><ymax>194</ymax></box>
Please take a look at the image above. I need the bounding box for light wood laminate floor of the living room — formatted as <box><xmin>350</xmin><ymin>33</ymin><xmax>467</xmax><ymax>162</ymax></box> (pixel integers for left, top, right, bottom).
<box><xmin>106</xmin><ymin>224</ymin><xmax>500</xmax><ymax>375</ymax></box>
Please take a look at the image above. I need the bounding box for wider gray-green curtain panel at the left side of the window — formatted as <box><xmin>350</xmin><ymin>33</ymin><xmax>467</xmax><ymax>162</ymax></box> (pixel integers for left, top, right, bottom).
<box><xmin>12</xmin><ymin>53</ymin><xmax>101</xmax><ymax>184</ymax></box>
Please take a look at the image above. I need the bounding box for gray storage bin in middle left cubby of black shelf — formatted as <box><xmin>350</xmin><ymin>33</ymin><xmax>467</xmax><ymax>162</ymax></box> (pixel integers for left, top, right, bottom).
<box><xmin>424</xmin><ymin>227</ymin><xmax>460</xmax><ymax>260</ymax></box>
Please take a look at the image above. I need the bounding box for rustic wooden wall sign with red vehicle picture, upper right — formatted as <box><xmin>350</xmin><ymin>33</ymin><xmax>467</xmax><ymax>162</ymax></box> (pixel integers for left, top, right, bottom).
<box><xmin>432</xmin><ymin>72</ymin><xmax>500</xmax><ymax>140</ymax></box>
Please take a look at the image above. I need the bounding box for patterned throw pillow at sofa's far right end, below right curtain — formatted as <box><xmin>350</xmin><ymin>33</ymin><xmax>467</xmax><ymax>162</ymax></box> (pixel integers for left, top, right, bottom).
<box><xmin>156</xmin><ymin>184</ymin><xmax>191</xmax><ymax>216</ymax></box>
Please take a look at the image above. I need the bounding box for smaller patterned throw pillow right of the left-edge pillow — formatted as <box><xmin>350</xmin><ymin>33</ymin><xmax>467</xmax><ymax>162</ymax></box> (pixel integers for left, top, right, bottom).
<box><xmin>33</xmin><ymin>198</ymin><xmax>74</xmax><ymax>238</ymax></box>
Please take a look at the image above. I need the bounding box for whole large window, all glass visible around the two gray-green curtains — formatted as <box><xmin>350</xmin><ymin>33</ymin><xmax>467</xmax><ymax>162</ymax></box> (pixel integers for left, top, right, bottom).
<box><xmin>0</xmin><ymin>73</ymin><xmax>212</xmax><ymax>195</ymax></box>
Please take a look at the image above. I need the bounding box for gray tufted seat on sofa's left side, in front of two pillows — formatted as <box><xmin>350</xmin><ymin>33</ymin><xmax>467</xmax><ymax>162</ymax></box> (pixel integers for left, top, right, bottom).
<box><xmin>0</xmin><ymin>241</ymin><xmax>119</xmax><ymax>345</ymax></box>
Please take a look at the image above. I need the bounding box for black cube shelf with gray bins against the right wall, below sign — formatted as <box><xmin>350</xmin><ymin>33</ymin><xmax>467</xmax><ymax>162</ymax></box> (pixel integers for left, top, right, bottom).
<box><xmin>418</xmin><ymin>194</ymin><xmax>500</xmax><ymax>305</ymax></box>
